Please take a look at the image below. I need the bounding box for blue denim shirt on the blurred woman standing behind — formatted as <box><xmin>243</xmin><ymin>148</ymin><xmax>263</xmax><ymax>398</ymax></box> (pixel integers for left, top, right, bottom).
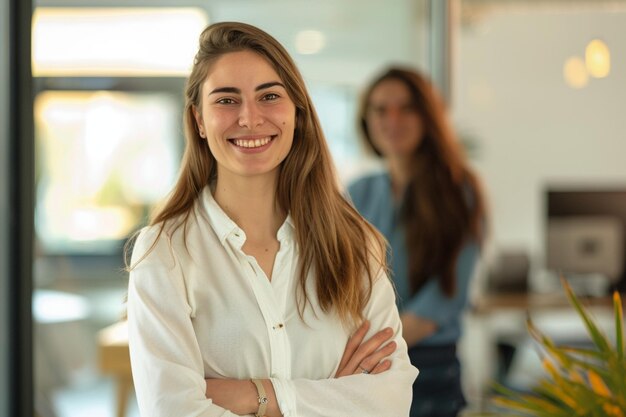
<box><xmin>348</xmin><ymin>172</ymin><xmax>480</xmax><ymax>345</ymax></box>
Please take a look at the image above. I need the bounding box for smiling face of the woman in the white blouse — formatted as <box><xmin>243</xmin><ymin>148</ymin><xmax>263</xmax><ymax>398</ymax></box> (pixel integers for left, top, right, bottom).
<box><xmin>194</xmin><ymin>51</ymin><xmax>296</xmax><ymax>179</ymax></box>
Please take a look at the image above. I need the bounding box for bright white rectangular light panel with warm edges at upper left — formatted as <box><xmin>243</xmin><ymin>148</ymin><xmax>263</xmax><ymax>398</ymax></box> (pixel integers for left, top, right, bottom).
<box><xmin>32</xmin><ymin>7</ymin><xmax>208</xmax><ymax>76</ymax></box>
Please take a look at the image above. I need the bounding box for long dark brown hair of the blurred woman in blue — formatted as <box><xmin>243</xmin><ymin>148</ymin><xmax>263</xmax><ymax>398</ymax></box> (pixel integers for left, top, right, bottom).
<box><xmin>358</xmin><ymin>68</ymin><xmax>485</xmax><ymax>297</ymax></box>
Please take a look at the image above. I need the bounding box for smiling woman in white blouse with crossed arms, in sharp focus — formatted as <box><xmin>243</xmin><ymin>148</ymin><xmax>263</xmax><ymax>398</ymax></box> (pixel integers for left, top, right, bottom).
<box><xmin>123</xmin><ymin>23</ymin><xmax>417</xmax><ymax>417</ymax></box>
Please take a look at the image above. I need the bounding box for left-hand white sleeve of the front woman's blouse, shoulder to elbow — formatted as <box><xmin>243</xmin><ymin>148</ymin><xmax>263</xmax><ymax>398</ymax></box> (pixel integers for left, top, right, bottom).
<box><xmin>128</xmin><ymin>229</ymin><xmax>236</xmax><ymax>417</ymax></box>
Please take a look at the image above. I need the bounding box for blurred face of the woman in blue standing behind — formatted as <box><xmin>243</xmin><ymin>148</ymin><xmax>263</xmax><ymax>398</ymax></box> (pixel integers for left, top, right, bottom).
<box><xmin>365</xmin><ymin>79</ymin><xmax>424</xmax><ymax>158</ymax></box>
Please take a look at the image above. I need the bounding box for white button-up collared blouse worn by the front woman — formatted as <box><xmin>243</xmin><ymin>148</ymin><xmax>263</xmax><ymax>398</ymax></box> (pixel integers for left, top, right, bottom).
<box><xmin>128</xmin><ymin>187</ymin><xmax>417</xmax><ymax>417</ymax></box>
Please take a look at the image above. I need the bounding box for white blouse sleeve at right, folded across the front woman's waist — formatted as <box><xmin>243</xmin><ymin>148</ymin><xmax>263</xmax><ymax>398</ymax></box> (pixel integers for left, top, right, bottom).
<box><xmin>272</xmin><ymin>274</ymin><xmax>418</xmax><ymax>417</ymax></box>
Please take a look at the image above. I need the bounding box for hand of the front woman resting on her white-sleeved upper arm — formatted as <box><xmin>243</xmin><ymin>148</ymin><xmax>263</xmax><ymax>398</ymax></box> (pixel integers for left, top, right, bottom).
<box><xmin>335</xmin><ymin>320</ymin><xmax>397</xmax><ymax>378</ymax></box>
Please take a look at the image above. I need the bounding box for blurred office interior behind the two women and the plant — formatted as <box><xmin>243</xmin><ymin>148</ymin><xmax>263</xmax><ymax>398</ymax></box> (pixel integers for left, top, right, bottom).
<box><xmin>0</xmin><ymin>0</ymin><xmax>626</xmax><ymax>417</ymax></box>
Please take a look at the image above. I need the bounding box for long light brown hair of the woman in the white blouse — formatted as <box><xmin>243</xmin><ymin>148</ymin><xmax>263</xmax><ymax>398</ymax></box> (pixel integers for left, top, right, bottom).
<box><xmin>132</xmin><ymin>22</ymin><xmax>386</xmax><ymax>322</ymax></box>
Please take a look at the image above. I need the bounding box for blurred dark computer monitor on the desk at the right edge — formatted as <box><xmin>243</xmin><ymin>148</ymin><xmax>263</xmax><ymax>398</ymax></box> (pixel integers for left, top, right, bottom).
<box><xmin>545</xmin><ymin>186</ymin><xmax>626</xmax><ymax>286</ymax></box>
